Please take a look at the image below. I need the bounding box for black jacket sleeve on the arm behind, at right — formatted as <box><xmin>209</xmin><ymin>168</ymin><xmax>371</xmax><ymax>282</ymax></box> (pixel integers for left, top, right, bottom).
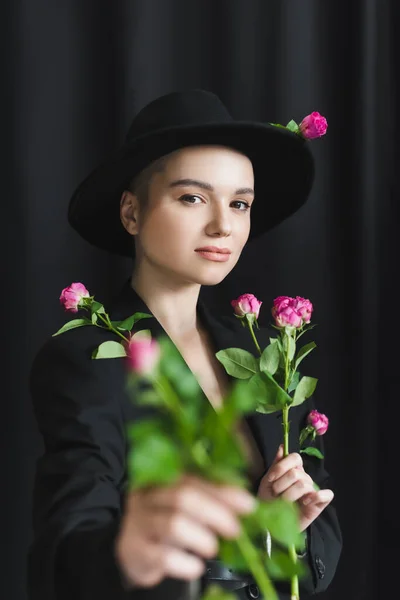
<box><xmin>289</xmin><ymin>398</ymin><xmax>342</xmax><ymax>594</ymax></box>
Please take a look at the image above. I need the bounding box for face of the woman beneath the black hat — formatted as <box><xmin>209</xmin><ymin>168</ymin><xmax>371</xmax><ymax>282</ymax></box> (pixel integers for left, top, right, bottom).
<box><xmin>123</xmin><ymin>146</ymin><xmax>254</xmax><ymax>285</ymax></box>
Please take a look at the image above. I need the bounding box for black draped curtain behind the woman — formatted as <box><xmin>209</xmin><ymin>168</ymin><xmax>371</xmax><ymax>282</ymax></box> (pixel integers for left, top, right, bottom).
<box><xmin>0</xmin><ymin>0</ymin><xmax>400</xmax><ymax>600</ymax></box>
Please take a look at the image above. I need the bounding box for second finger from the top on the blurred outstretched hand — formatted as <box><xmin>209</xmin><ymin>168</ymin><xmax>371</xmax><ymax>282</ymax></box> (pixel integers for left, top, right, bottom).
<box><xmin>145</xmin><ymin>512</ymin><xmax>218</xmax><ymax>559</ymax></box>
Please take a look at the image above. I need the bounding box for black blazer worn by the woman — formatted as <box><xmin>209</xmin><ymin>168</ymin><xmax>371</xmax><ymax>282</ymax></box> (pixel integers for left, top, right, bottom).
<box><xmin>28</xmin><ymin>280</ymin><xmax>341</xmax><ymax>600</ymax></box>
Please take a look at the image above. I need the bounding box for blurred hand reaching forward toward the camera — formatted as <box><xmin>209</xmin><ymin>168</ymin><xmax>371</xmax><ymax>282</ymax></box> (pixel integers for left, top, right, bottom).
<box><xmin>115</xmin><ymin>475</ymin><xmax>255</xmax><ymax>587</ymax></box>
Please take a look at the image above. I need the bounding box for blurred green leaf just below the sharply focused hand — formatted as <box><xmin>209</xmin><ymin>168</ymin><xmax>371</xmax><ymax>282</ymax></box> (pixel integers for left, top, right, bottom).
<box><xmin>256</xmin><ymin>498</ymin><xmax>303</xmax><ymax>548</ymax></box>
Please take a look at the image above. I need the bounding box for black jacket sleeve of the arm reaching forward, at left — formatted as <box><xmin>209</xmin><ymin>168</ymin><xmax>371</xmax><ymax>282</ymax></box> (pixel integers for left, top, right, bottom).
<box><xmin>27</xmin><ymin>328</ymin><xmax>189</xmax><ymax>600</ymax></box>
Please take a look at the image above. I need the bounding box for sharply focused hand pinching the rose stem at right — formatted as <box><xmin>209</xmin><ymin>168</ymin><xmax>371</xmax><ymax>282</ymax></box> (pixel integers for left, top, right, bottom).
<box><xmin>257</xmin><ymin>445</ymin><xmax>334</xmax><ymax>531</ymax></box>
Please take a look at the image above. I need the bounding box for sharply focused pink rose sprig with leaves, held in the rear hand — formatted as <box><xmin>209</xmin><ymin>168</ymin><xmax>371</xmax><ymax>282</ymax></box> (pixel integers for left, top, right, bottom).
<box><xmin>216</xmin><ymin>294</ymin><xmax>329</xmax><ymax>600</ymax></box>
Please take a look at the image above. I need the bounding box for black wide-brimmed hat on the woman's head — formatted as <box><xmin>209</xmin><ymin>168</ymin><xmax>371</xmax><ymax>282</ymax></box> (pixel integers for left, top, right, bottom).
<box><xmin>68</xmin><ymin>90</ymin><xmax>314</xmax><ymax>257</ymax></box>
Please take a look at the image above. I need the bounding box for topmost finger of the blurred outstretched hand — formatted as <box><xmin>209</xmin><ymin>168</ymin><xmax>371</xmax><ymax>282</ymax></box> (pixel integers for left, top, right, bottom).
<box><xmin>147</xmin><ymin>485</ymin><xmax>240</xmax><ymax>538</ymax></box>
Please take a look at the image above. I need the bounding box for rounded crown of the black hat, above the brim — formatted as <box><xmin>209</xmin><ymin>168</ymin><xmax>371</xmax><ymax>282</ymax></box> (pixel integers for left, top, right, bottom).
<box><xmin>126</xmin><ymin>90</ymin><xmax>233</xmax><ymax>142</ymax></box>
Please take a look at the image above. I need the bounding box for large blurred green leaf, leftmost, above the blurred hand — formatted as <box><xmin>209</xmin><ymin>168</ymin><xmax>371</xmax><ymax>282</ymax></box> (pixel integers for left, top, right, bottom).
<box><xmin>128</xmin><ymin>419</ymin><xmax>183</xmax><ymax>488</ymax></box>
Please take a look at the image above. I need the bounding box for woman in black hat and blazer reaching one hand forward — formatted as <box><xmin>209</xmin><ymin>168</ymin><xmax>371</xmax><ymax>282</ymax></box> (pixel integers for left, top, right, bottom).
<box><xmin>28</xmin><ymin>90</ymin><xmax>341</xmax><ymax>600</ymax></box>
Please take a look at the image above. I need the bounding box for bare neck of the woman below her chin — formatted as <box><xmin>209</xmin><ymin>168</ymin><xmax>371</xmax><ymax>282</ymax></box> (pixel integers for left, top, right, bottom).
<box><xmin>131</xmin><ymin>265</ymin><xmax>200</xmax><ymax>339</ymax></box>
